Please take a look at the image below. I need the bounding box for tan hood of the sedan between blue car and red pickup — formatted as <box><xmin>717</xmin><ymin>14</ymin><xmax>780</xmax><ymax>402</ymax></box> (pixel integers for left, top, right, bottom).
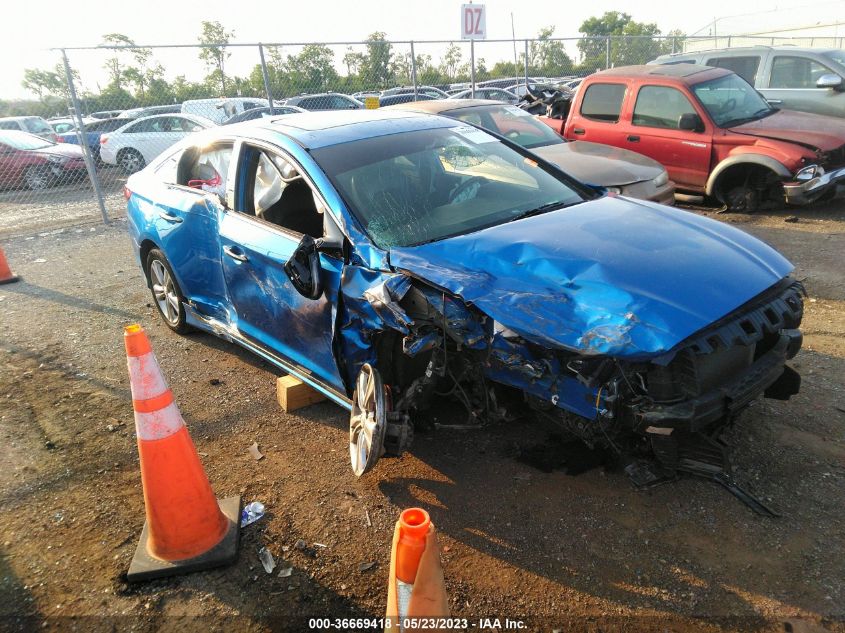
<box><xmin>531</xmin><ymin>141</ymin><xmax>663</xmax><ymax>187</ymax></box>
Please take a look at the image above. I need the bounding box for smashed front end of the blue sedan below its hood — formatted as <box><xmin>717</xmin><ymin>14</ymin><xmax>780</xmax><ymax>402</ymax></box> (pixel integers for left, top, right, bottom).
<box><xmin>341</xmin><ymin>260</ymin><xmax>804</xmax><ymax>512</ymax></box>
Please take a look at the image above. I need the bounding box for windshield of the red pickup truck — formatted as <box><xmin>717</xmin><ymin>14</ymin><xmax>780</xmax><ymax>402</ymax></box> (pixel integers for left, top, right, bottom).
<box><xmin>692</xmin><ymin>73</ymin><xmax>776</xmax><ymax>127</ymax></box>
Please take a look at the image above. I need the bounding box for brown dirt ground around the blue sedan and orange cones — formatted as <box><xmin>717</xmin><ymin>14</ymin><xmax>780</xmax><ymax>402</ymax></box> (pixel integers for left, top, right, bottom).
<box><xmin>0</xmin><ymin>202</ymin><xmax>845</xmax><ymax>631</ymax></box>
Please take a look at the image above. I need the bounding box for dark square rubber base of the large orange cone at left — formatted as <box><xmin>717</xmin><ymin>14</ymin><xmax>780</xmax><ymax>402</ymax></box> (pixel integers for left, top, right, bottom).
<box><xmin>126</xmin><ymin>497</ymin><xmax>241</xmax><ymax>582</ymax></box>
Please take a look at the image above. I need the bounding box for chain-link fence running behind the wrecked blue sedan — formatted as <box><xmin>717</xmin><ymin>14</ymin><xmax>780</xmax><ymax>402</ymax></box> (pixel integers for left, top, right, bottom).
<box><xmin>0</xmin><ymin>36</ymin><xmax>843</xmax><ymax>234</ymax></box>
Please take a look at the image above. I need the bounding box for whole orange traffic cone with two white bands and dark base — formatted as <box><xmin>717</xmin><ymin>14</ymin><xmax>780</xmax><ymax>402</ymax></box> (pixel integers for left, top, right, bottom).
<box><xmin>124</xmin><ymin>325</ymin><xmax>241</xmax><ymax>582</ymax></box>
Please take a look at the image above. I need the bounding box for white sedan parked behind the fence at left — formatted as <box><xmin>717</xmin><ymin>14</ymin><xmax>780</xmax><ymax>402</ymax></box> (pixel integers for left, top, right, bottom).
<box><xmin>100</xmin><ymin>114</ymin><xmax>215</xmax><ymax>174</ymax></box>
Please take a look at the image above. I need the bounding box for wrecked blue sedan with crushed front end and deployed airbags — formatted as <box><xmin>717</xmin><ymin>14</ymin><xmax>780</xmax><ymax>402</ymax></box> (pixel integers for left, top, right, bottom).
<box><xmin>128</xmin><ymin>110</ymin><xmax>803</xmax><ymax>494</ymax></box>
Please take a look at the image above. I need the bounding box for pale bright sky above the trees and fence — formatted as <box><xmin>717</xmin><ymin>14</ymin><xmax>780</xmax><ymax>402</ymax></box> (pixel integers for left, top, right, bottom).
<box><xmin>0</xmin><ymin>0</ymin><xmax>845</xmax><ymax>98</ymax></box>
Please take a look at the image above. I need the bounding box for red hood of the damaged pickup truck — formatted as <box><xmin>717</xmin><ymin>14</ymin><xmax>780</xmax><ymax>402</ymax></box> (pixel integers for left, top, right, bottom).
<box><xmin>731</xmin><ymin>110</ymin><xmax>845</xmax><ymax>152</ymax></box>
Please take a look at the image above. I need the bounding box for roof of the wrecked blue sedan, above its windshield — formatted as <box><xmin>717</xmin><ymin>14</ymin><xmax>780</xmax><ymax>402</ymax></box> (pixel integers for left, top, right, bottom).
<box><xmin>244</xmin><ymin>109</ymin><xmax>462</xmax><ymax>149</ymax></box>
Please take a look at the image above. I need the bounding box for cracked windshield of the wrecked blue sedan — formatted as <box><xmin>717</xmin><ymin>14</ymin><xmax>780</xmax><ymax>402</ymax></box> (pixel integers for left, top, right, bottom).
<box><xmin>312</xmin><ymin>124</ymin><xmax>595</xmax><ymax>249</ymax></box>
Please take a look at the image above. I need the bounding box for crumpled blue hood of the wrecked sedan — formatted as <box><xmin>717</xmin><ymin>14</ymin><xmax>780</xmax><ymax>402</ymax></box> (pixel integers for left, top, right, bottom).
<box><xmin>390</xmin><ymin>197</ymin><xmax>793</xmax><ymax>359</ymax></box>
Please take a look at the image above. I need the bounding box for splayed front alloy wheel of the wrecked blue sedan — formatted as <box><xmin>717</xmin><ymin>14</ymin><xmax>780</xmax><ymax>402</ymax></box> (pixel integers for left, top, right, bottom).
<box><xmin>349</xmin><ymin>363</ymin><xmax>387</xmax><ymax>477</ymax></box>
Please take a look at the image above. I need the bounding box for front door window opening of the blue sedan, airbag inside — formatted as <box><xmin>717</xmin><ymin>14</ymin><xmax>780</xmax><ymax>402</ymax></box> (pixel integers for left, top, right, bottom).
<box><xmin>236</xmin><ymin>146</ymin><xmax>323</xmax><ymax>238</ymax></box>
